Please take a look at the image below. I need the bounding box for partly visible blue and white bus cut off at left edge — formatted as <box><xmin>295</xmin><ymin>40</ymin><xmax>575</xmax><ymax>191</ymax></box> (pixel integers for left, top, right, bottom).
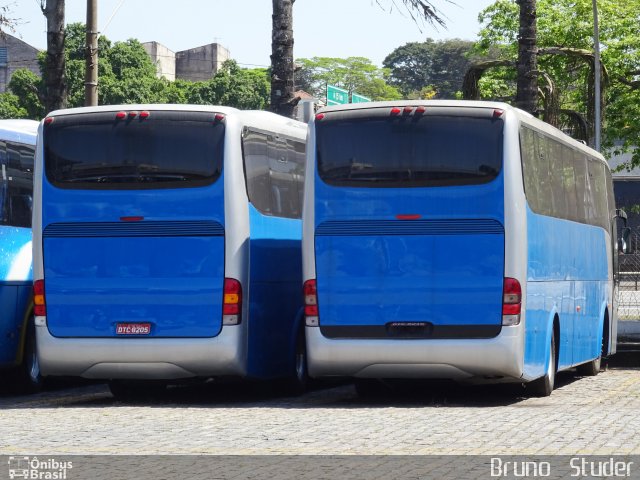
<box><xmin>0</xmin><ymin>120</ymin><xmax>42</xmax><ymax>391</ymax></box>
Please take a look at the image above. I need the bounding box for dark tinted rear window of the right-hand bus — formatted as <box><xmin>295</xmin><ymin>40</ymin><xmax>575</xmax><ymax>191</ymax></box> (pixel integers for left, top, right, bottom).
<box><xmin>316</xmin><ymin>114</ymin><xmax>503</xmax><ymax>187</ymax></box>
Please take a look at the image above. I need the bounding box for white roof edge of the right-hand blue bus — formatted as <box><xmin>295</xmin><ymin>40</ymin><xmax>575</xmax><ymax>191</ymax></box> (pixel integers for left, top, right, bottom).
<box><xmin>317</xmin><ymin>100</ymin><xmax>608</xmax><ymax>166</ymax></box>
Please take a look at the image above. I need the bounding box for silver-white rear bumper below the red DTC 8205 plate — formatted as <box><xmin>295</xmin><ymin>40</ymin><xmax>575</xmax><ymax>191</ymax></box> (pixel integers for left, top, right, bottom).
<box><xmin>36</xmin><ymin>318</ymin><xmax>246</xmax><ymax>380</ymax></box>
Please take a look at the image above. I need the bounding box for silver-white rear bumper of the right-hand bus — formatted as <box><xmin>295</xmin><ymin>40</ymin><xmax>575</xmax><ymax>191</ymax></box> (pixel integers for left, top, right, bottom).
<box><xmin>306</xmin><ymin>325</ymin><xmax>524</xmax><ymax>381</ymax></box>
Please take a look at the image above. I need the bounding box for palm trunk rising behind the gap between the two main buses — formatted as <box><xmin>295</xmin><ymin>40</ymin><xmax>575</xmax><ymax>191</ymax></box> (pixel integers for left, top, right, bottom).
<box><xmin>271</xmin><ymin>0</ymin><xmax>295</xmax><ymax>117</ymax></box>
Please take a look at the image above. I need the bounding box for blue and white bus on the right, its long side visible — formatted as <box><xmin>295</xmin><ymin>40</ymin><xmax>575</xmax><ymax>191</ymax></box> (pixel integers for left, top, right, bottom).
<box><xmin>302</xmin><ymin>101</ymin><xmax>618</xmax><ymax>396</ymax></box>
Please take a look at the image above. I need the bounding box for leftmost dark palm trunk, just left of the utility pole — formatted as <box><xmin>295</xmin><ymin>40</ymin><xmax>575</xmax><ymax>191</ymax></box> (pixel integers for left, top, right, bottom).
<box><xmin>40</xmin><ymin>0</ymin><xmax>67</xmax><ymax>112</ymax></box>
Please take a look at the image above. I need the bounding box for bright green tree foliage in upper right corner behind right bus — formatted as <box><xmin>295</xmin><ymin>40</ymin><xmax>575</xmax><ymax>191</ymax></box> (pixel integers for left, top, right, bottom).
<box><xmin>476</xmin><ymin>0</ymin><xmax>640</xmax><ymax>165</ymax></box>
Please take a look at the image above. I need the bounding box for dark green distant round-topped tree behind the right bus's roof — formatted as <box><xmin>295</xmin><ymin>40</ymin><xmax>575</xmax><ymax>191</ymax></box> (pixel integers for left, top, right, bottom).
<box><xmin>383</xmin><ymin>38</ymin><xmax>473</xmax><ymax>98</ymax></box>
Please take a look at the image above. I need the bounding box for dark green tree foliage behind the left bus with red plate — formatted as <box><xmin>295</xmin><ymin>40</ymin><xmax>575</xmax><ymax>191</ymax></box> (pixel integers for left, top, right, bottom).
<box><xmin>0</xmin><ymin>23</ymin><xmax>269</xmax><ymax>119</ymax></box>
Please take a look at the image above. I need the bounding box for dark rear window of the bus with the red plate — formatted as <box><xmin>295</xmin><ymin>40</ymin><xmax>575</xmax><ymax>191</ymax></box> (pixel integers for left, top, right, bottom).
<box><xmin>44</xmin><ymin>111</ymin><xmax>224</xmax><ymax>189</ymax></box>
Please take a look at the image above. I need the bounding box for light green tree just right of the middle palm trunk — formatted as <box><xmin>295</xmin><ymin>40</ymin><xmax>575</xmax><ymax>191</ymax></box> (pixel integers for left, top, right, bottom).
<box><xmin>297</xmin><ymin>57</ymin><xmax>402</xmax><ymax>100</ymax></box>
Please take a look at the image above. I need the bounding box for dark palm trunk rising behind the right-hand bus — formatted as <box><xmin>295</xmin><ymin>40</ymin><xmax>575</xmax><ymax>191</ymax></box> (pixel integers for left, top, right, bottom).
<box><xmin>516</xmin><ymin>0</ymin><xmax>538</xmax><ymax>114</ymax></box>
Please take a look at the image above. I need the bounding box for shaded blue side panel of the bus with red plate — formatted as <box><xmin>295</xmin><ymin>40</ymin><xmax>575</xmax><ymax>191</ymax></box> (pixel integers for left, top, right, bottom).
<box><xmin>248</xmin><ymin>205</ymin><xmax>302</xmax><ymax>378</ymax></box>
